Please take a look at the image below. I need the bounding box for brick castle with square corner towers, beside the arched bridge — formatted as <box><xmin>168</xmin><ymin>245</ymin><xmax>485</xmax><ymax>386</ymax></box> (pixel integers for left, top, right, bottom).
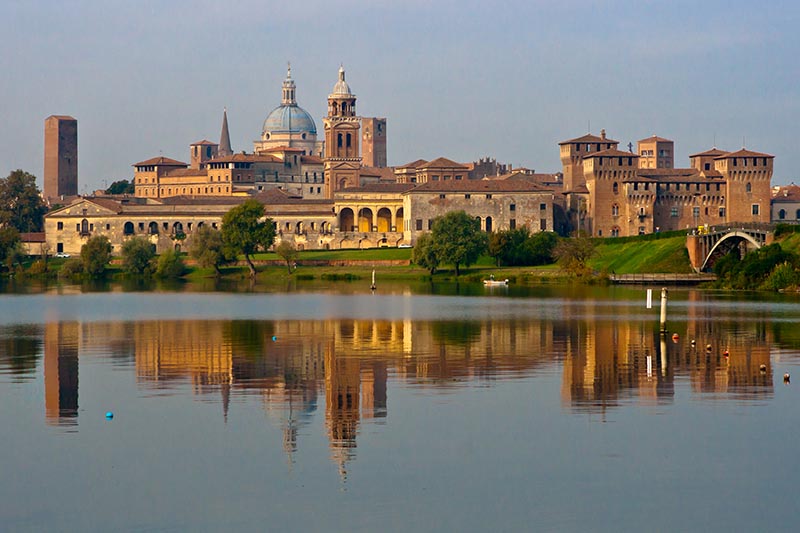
<box><xmin>559</xmin><ymin>132</ymin><xmax>773</xmax><ymax>237</ymax></box>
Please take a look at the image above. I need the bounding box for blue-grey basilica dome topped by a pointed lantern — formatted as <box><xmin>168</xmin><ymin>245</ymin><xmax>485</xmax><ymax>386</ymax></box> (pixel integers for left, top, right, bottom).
<box><xmin>253</xmin><ymin>65</ymin><xmax>324</xmax><ymax>157</ymax></box>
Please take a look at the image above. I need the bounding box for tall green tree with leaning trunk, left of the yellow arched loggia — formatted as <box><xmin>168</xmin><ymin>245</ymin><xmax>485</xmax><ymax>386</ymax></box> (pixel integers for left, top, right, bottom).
<box><xmin>222</xmin><ymin>199</ymin><xmax>275</xmax><ymax>277</ymax></box>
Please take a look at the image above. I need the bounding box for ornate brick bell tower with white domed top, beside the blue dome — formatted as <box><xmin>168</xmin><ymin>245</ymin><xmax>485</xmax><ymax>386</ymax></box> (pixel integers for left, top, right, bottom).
<box><xmin>323</xmin><ymin>67</ymin><xmax>361</xmax><ymax>199</ymax></box>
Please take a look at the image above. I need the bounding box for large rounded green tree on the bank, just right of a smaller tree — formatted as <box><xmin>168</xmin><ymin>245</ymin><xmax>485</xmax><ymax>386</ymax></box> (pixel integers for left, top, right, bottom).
<box><xmin>431</xmin><ymin>211</ymin><xmax>488</xmax><ymax>276</ymax></box>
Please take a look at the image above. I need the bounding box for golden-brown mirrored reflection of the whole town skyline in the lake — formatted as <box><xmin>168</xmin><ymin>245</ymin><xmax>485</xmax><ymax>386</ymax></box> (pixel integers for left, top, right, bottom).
<box><xmin>18</xmin><ymin>298</ymin><xmax>792</xmax><ymax>468</ymax></box>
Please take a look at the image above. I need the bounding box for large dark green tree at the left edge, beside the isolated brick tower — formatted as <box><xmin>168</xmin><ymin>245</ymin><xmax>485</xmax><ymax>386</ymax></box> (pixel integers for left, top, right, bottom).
<box><xmin>0</xmin><ymin>170</ymin><xmax>47</xmax><ymax>233</ymax></box>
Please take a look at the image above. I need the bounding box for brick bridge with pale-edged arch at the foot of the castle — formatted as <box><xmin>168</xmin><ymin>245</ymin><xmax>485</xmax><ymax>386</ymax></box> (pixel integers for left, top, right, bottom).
<box><xmin>686</xmin><ymin>224</ymin><xmax>774</xmax><ymax>272</ymax></box>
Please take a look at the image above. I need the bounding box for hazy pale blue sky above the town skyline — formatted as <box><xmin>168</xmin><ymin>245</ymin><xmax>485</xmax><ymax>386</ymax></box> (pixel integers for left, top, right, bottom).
<box><xmin>0</xmin><ymin>0</ymin><xmax>800</xmax><ymax>192</ymax></box>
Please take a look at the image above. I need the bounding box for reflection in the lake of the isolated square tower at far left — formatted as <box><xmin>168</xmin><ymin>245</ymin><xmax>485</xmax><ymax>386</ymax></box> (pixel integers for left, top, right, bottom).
<box><xmin>44</xmin><ymin>322</ymin><xmax>80</xmax><ymax>425</ymax></box>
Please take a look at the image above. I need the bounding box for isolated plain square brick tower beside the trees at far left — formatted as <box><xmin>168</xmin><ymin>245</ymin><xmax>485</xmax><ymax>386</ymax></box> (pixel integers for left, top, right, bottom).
<box><xmin>44</xmin><ymin>115</ymin><xmax>78</xmax><ymax>201</ymax></box>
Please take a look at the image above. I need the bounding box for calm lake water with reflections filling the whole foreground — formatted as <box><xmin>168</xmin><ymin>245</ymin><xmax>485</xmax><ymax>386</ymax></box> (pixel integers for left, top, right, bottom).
<box><xmin>0</xmin><ymin>283</ymin><xmax>800</xmax><ymax>531</ymax></box>
